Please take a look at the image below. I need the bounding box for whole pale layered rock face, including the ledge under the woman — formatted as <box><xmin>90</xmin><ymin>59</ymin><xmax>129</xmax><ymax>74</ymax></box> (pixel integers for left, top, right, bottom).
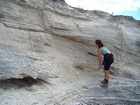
<box><xmin>0</xmin><ymin>0</ymin><xmax>140</xmax><ymax>105</ymax></box>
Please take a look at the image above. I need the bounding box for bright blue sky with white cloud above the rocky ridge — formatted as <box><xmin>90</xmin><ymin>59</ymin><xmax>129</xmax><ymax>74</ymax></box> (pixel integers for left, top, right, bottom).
<box><xmin>65</xmin><ymin>0</ymin><xmax>140</xmax><ymax>20</ymax></box>
